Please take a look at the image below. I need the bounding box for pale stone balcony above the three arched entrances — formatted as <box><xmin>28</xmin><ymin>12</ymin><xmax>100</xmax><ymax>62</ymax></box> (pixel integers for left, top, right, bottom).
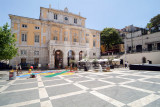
<box><xmin>48</xmin><ymin>40</ymin><xmax>89</xmax><ymax>48</ymax></box>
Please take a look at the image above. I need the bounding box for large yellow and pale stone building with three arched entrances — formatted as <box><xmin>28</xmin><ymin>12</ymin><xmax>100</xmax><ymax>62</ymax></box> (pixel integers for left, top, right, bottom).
<box><xmin>9</xmin><ymin>7</ymin><xmax>100</xmax><ymax>68</ymax></box>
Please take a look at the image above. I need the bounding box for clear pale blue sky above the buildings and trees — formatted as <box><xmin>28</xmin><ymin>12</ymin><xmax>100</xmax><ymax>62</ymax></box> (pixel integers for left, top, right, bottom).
<box><xmin>0</xmin><ymin>0</ymin><xmax>160</xmax><ymax>30</ymax></box>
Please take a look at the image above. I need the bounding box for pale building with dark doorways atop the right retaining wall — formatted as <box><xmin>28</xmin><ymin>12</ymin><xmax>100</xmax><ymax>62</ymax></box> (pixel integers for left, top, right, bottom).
<box><xmin>126</xmin><ymin>32</ymin><xmax>160</xmax><ymax>52</ymax></box>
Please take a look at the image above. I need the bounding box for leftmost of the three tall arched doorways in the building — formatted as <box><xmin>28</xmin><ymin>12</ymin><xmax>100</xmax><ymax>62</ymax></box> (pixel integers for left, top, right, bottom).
<box><xmin>55</xmin><ymin>50</ymin><xmax>63</xmax><ymax>69</ymax></box>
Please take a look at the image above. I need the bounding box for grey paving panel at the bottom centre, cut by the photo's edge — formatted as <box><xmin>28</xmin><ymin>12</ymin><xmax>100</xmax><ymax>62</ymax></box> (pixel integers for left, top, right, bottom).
<box><xmin>51</xmin><ymin>93</ymin><xmax>116</xmax><ymax>107</ymax></box>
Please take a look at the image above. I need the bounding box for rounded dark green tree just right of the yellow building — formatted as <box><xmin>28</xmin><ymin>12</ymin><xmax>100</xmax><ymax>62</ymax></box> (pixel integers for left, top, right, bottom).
<box><xmin>101</xmin><ymin>28</ymin><xmax>122</xmax><ymax>49</ymax></box>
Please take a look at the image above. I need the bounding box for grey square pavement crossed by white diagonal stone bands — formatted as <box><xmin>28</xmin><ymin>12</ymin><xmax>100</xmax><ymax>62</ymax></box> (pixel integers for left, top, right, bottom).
<box><xmin>0</xmin><ymin>68</ymin><xmax>160</xmax><ymax>107</ymax></box>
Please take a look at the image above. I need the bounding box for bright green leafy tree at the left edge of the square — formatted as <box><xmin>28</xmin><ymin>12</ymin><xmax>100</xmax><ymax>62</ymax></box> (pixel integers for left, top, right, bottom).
<box><xmin>0</xmin><ymin>23</ymin><xmax>18</xmax><ymax>60</ymax></box>
